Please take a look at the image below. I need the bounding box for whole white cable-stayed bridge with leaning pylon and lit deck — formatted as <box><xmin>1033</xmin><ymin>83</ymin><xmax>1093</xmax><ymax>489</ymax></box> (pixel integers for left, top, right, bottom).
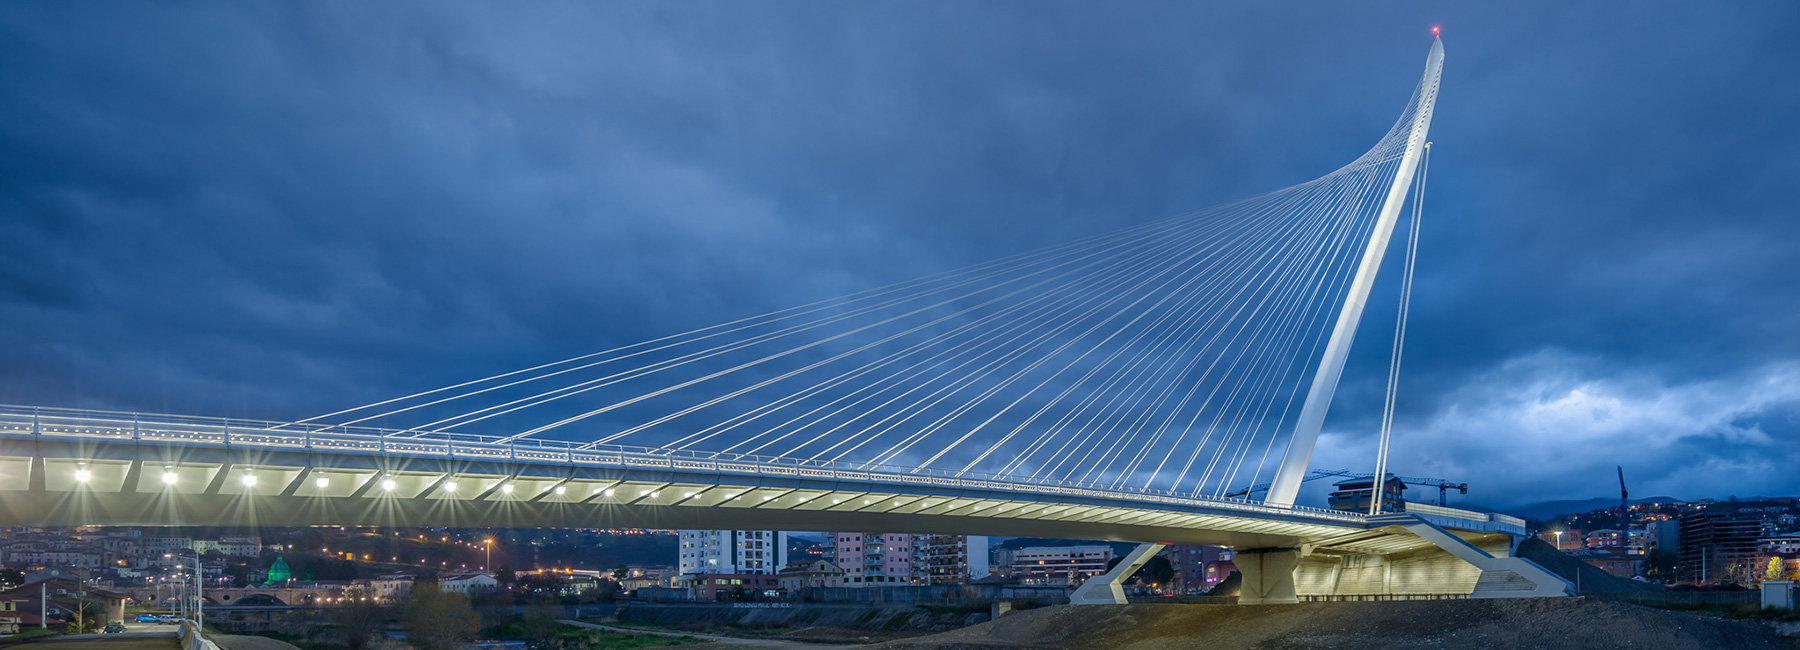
<box><xmin>0</xmin><ymin>36</ymin><xmax>1568</xmax><ymax>603</ymax></box>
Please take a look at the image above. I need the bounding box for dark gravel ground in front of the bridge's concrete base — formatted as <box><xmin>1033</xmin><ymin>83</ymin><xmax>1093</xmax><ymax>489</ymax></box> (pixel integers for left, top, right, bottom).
<box><xmin>878</xmin><ymin>598</ymin><xmax>1800</xmax><ymax>650</ymax></box>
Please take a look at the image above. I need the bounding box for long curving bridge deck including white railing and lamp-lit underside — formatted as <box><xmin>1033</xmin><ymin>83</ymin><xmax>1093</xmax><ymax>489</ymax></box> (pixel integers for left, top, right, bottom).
<box><xmin>0</xmin><ymin>407</ymin><xmax>1505</xmax><ymax>547</ymax></box>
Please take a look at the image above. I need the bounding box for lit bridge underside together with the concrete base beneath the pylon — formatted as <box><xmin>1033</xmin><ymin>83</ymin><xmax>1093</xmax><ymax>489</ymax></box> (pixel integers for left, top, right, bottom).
<box><xmin>0</xmin><ymin>436</ymin><xmax>1568</xmax><ymax>603</ymax></box>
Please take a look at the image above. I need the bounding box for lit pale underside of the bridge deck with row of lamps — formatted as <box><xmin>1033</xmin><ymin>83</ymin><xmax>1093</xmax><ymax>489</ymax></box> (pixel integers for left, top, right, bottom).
<box><xmin>0</xmin><ymin>439</ymin><xmax>1361</xmax><ymax>547</ymax></box>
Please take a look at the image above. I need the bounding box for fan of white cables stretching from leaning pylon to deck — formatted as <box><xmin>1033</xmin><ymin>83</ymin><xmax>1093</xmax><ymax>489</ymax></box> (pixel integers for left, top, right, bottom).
<box><xmin>277</xmin><ymin>62</ymin><xmax>1431</xmax><ymax>497</ymax></box>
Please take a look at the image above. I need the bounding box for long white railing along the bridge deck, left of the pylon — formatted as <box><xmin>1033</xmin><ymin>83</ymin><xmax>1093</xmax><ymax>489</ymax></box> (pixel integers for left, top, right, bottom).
<box><xmin>0</xmin><ymin>405</ymin><xmax>1366</xmax><ymax>524</ymax></box>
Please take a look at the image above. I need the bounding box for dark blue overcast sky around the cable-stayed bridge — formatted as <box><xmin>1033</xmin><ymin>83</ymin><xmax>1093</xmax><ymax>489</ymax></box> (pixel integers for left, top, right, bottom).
<box><xmin>0</xmin><ymin>0</ymin><xmax>1800</xmax><ymax>506</ymax></box>
